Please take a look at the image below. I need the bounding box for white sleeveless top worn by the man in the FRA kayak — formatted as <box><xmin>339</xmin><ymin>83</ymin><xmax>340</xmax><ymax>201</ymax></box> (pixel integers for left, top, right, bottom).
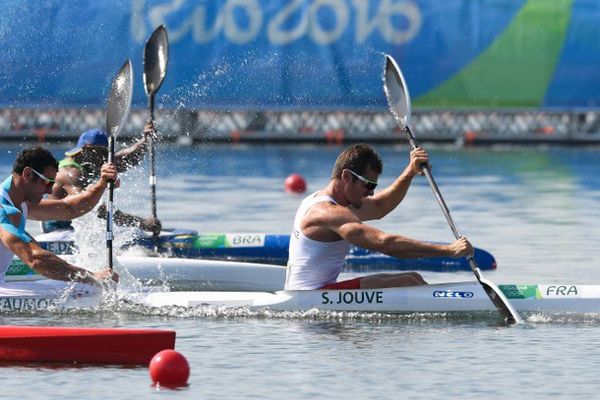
<box><xmin>285</xmin><ymin>192</ymin><xmax>350</xmax><ymax>290</ymax></box>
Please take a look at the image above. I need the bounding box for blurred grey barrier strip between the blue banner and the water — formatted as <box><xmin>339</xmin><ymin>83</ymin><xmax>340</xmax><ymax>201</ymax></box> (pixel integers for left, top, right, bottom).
<box><xmin>0</xmin><ymin>109</ymin><xmax>600</xmax><ymax>144</ymax></box>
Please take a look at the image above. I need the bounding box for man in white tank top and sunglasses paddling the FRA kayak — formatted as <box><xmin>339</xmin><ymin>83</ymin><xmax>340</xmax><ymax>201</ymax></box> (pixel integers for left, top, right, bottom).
<box><xmin>285</xmin><ymin>144</ymin><xmax>473</xmax><ymax>290</ymax></box>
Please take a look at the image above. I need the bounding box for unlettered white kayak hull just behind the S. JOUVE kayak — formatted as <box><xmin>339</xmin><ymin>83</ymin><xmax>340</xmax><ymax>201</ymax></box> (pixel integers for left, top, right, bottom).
<box><xmin>6</xmin><ymin>256</ymin><xmax>285</xmax><ymax>291</ymax></box>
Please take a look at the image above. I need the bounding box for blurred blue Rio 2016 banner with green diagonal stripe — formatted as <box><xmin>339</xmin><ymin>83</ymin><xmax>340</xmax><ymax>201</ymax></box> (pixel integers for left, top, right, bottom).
<box><xmin>0</xmin><ymin>0</ymin><xmax>600</xmax><ymax>110</ymax></box>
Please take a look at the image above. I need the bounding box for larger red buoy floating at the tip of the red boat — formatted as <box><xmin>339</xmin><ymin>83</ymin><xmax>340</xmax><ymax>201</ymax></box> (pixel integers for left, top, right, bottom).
<box><xmin>148</xmin><ymin>350</ymin><xmax>190</xmax><ymax>387</ymax></box>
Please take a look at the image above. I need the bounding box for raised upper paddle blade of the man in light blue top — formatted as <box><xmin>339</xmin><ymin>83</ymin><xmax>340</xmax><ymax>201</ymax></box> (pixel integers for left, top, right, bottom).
<box><xmin>106</xmin><ymin>59</ymin><xmax>133</xmax><ymax>137</ymax></box>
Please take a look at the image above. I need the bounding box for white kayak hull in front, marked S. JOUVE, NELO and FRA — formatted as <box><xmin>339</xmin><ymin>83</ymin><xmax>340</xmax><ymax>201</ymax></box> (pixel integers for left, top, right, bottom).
<box><xmin>0</xmin><ymin>281</ymin><xmax>600</xmax><ymax>313</ymax></box>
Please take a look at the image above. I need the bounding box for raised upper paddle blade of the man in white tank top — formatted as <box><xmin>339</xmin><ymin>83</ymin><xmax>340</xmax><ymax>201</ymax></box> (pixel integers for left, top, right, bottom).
<box><xmin>383</xmin><ymin>54</ymin><xmax>410</xmax><ymax>129</ymax></box>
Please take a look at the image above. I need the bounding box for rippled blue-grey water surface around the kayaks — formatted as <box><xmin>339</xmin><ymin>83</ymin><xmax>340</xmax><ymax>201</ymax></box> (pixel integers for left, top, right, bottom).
<box><xmin>0</xmin><ymin>144</ymin><xmax>600</xmax><ymax>399</ymax></box>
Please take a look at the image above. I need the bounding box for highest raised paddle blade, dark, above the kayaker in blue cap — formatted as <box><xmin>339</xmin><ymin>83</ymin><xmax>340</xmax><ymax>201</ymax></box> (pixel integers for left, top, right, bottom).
<box><xmin>144</xmin><ymin>25</ymin><xmax>169</xmax><ymax>95</ymax></box>
